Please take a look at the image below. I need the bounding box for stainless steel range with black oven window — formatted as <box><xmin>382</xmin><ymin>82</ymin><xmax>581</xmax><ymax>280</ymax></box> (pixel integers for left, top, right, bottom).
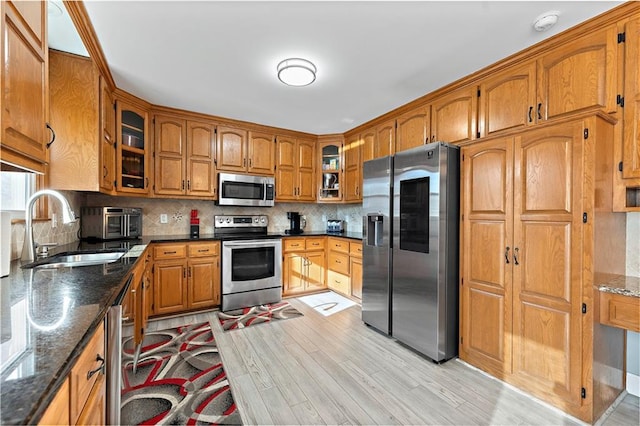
<box><xmin>214</xmin><ymin>215</ymin><xmax>282</xmax><ymax>311</ymax></box>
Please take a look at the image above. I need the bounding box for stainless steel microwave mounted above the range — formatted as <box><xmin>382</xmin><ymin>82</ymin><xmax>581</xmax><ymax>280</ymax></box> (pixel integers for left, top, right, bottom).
<box><xmin>218</xmin><ymin>173</ymin><xmax>276</xmax><ymax>207</ymax></box>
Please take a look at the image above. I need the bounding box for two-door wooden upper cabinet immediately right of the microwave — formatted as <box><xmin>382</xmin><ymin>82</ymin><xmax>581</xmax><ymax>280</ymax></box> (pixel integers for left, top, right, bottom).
<box><xmin>275</xmin><ymin>136</ymin><xmax>317</xmax><ymax>201</ymax></box>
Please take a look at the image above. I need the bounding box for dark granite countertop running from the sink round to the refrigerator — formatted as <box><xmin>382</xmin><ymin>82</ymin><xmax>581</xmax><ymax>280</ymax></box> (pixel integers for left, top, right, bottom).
<box><xmin>0</xmin><ymin>231</ymin><xmax>362</xmax><ymax>424</ymax></box>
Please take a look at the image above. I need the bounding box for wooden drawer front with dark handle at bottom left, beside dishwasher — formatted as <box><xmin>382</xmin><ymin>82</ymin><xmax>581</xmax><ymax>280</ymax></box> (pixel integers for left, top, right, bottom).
<box><xmin>69</xmin><ymin>327</ymin><xmax>106</xmax><ymax>424</ymax></box>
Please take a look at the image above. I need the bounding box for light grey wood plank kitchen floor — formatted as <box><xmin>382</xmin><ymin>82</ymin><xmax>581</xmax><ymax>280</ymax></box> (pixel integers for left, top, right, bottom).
<box><xmin>148</xmin><ymin>299</ymin><xmax>640</xmax><ymax>426</ymax></box>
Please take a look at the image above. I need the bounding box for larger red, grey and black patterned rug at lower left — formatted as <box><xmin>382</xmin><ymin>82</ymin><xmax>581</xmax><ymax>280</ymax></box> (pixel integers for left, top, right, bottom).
<box><xmin>121</xmin><ymin>323</ymin><xmax>242</xmax><ymax>425</ymax></box>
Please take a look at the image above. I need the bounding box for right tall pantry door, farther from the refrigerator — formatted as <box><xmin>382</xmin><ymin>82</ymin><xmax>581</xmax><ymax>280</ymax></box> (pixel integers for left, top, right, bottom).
<box><xmin>513</xmin><ymin>122</ymin><xmax>585</xmax><ymax>407</ymax></box>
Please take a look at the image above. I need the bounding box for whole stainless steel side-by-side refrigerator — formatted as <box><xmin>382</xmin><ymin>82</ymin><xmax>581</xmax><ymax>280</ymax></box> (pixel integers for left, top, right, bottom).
<box><xmin>362</xmin><ymin>142</ymin><xmax>460</xmax><ymax>362</ymax></box>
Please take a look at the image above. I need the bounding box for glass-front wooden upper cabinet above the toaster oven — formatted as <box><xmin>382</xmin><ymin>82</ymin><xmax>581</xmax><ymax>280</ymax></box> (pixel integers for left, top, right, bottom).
<box><xmin>116</xmin><ymin>98</ymin><xmax>151</xmax><ymax>195</ymax></box>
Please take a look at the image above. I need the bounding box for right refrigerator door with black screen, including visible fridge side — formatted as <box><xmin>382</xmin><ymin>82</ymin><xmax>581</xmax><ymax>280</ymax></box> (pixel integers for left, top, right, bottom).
<box><xmin>392</xmin><ymin>142</ymin><xmax>460</xmax><ymax>361</ymax></box>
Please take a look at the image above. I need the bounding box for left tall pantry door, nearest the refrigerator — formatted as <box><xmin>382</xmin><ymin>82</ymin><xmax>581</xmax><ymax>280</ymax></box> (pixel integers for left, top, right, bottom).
<box><xmin>460</xmin><ymin>138</ymin><xmax>513</xmax><ymax>377</ymax></box>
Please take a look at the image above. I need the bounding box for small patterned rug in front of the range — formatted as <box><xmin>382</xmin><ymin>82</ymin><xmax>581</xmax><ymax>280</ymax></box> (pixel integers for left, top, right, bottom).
<box><xmin>218</xmin><ymin>301</ymin><xmax>303</xmax><ymax>331</ymax></box>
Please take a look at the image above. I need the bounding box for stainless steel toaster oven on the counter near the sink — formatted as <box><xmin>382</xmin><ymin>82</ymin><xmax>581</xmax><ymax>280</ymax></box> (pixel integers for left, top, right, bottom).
<box><xmin>80</xmin><ymin>207</ymin><xmax>142</xmax><ymax>240</ymax></box>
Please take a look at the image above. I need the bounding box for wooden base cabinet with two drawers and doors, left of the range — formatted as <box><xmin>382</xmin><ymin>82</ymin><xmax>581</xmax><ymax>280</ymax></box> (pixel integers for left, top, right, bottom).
<box><xmin>153</xmin><ymin>242</ymin><xmax>220</xmax><ymax>315</ymax></box>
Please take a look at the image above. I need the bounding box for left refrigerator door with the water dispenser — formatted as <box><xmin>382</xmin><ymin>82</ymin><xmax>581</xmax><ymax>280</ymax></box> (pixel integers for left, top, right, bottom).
<box><xmin>362</xmin><ymin>157</ymin><xmax>393</xmax><ymax>334</ymax></box>
